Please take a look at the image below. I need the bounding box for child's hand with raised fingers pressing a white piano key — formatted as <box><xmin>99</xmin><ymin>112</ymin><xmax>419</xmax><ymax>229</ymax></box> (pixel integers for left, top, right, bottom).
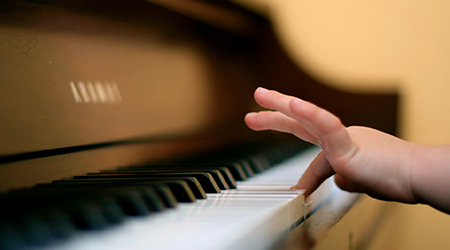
<box><xmin>245</xmin><ymin>88</ymin><xmax>421</xmax><ymax>203</ymax></box>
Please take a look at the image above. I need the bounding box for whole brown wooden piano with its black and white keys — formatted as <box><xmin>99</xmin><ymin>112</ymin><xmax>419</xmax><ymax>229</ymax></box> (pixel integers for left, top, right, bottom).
<box><xmin>0</xmin><ymin>0</ymin><xmax>399</xmax><ymax>250</ymax></box>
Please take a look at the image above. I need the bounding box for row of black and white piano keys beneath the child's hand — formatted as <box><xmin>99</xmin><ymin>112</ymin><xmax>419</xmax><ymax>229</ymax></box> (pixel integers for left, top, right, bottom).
<box><xmin>0</xmin><ymin>144</ymin><xmax>326</xmax><ymax>250</ymax></box>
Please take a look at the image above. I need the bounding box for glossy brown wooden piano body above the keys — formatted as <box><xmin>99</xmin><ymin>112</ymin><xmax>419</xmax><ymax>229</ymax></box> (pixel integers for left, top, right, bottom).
<box><xmin>0</xmin><ymin>0</ymin><xmax>398</xmax><ymax>248</ymax></box>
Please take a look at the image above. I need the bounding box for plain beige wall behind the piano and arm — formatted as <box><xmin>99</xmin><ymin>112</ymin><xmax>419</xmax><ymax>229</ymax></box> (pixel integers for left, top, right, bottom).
<box><xmin>236</xmin><ymin>0</ymin><xmax>450</xmax><ymax>249</ymax></box>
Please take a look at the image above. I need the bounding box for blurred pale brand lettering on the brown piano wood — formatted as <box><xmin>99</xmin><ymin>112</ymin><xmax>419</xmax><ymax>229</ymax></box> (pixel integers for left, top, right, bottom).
<box><xmin>70</xmin><ymin>81</ymin><xmax>122</xmax><ymax>104</ymax></box>
